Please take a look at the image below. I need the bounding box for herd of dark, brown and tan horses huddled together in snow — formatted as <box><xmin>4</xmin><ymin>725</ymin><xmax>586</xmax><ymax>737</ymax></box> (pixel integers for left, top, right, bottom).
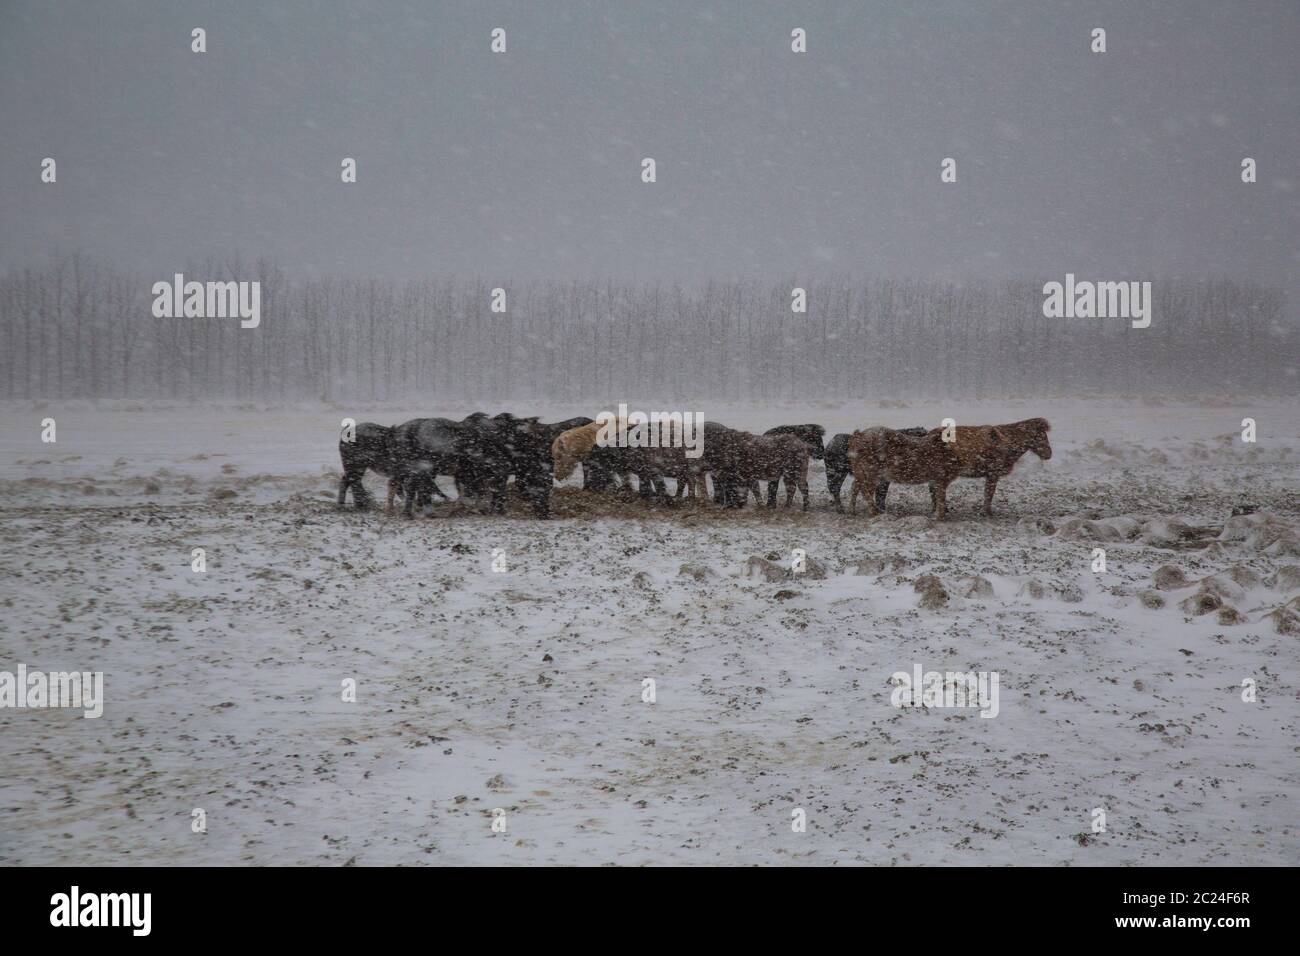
<box><xmin>338</xmin><ymin>412</ymin><xmax>1052</xmax><ymax>520</ymax></box>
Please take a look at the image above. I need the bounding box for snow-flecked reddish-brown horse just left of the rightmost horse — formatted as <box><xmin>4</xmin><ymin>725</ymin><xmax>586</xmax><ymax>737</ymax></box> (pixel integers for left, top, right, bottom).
<box><xmin>849</xmin><ymin>428</ymin><xmax>962</xmax><ymax>520</ymax></box>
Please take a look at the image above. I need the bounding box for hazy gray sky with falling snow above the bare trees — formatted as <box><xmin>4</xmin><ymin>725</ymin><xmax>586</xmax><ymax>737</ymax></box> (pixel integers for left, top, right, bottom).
<box><xmin>0</xmin><ymin>0</ymin><xmax>1300</xmax><ymax>306</ymax></box>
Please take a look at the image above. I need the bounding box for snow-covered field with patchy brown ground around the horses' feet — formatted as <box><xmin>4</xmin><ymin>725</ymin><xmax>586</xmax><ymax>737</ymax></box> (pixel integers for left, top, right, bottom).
<box><xmin>0</xmin><ymin>399</ymin><xmax>1300</xmax><ymax>865</ymax></box>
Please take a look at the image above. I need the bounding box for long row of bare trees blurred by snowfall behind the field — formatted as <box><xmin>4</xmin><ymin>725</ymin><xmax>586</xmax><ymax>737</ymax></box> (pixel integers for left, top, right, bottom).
<box><xmin>0</xmin><ymin>255</ymin><xmax>1297</xmax><ymax>407</ymax></box>
